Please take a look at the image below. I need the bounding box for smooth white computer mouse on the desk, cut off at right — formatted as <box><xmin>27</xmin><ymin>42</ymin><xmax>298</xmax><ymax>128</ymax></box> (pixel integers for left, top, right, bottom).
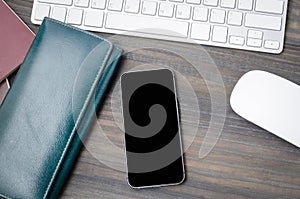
<box><xmin>230</xmin><ymin>70</ymin><xmax>300</xmax><ymax>147</ymax></box>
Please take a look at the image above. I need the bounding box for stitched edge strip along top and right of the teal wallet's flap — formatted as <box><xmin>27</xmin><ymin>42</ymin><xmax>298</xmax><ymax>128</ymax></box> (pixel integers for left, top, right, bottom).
<box><xmin>43</xmin><ymin>18</ymin><xmax>112</xmax><ymax>198</ymax></box>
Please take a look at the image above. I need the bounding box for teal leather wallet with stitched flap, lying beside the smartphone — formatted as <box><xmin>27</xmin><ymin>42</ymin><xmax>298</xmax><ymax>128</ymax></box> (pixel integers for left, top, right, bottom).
<box><xmin>0</xmin><ymin>18</ymin><xmax>122</xmax><ymax>199</ymax></box>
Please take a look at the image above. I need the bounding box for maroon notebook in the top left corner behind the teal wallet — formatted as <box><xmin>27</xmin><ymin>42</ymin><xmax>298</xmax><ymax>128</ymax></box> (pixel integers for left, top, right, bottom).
<box><xmin>0</xmin><ymin>0</ymin><xmax>34</xmax><ymax>82</ymax></box>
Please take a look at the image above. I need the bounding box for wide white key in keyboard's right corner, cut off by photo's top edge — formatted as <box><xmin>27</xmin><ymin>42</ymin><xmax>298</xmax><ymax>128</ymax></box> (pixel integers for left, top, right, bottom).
<box><xmin>255</xmin><ymin>0</ymin><xmax>284</xmax><ymax>14</ymax></box>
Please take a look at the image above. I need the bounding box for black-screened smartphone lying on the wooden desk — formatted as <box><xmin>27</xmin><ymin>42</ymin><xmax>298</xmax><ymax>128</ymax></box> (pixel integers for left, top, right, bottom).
<box><xmin>121</xmin><ymin>69</ymin><xmax>185</xmax><ymax>188</ymax></box>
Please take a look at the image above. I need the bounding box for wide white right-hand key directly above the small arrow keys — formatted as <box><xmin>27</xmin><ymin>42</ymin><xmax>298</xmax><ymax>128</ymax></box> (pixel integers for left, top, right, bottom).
<box><xmin>245</xmin><ymin>14</ymin><xmax>281</xmax><ymax>30</ymax></box>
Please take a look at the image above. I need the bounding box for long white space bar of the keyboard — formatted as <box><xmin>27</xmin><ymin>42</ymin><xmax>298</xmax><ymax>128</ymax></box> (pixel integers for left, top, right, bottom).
<box><xmin>105</xmin><ymin>13</ymin><xmax>189</xmax><ymax>38</ymax></box>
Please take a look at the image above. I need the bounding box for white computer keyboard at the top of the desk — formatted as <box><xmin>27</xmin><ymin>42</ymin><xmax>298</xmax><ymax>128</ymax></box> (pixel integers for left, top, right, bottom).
<box><xmin>31</xmin><ymin>0</ymin><xmax>288</xmax><ymax>53</ymax></box>
